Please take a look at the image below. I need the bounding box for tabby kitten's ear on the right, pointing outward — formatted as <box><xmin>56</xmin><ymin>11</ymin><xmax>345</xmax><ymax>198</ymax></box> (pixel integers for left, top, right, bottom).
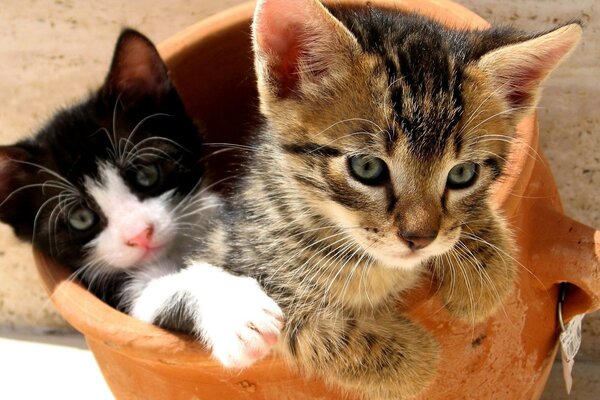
<box><xmin>477</xmin><ymin>24</ymin><xmax>582</xmax><ymax>119</ymax></box>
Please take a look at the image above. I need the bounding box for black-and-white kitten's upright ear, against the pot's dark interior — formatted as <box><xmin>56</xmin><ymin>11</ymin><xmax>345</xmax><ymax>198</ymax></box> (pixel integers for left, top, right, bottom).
<box><xmin>103</xmin><ymin>29</ymin><xmax>171</xmax><ymax>103</ymax></box>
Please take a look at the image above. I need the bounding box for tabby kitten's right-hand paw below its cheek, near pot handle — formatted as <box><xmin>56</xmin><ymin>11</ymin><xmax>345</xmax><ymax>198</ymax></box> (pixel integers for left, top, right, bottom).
<box><xmin>434</xmin><ymin>209</ymin><xmax>517</xmax><ymax>323</ymax></box>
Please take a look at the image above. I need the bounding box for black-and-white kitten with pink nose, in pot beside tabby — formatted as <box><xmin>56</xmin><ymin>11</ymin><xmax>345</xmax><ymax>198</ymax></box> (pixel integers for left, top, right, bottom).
<box><xmin>0</xmin><ymin>30</ymin><xmax>282</xmax><ymax>367</ymax></box>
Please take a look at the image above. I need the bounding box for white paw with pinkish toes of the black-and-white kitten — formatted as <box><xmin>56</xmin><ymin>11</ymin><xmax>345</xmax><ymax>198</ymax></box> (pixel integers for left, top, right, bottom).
<box><xmin>202</xmin><ymin>275</ymin><xmax>283</xmax><ymax>368</ymax></box>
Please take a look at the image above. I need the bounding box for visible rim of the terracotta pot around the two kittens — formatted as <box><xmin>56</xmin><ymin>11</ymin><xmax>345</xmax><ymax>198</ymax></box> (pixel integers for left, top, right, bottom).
<box><xmin>34</xmin><ymin>0</ymin><xmax>537</xmax><ymax>362</ymax></box>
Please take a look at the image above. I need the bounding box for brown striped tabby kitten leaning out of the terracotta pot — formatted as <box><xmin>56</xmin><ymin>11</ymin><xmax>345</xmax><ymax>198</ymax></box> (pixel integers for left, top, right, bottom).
<box><xmin>193</xmin><ymin>0</ymin><xmax>581</xmax><ymax>399</ymax></box>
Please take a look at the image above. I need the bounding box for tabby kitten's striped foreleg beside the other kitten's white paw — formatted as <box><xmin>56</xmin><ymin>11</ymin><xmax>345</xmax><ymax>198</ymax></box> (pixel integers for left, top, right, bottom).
<box><xmin>280</xmin><ymin>307</ymin><xmax>440</xmax><ymax>400</ymax></box>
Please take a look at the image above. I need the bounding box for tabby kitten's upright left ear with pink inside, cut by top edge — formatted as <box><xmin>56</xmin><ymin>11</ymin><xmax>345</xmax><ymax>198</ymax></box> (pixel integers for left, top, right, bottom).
<box><xmin>253</xmin><ymin>0</ymin><xmax>360</xmax><ymax>99</ymax></box>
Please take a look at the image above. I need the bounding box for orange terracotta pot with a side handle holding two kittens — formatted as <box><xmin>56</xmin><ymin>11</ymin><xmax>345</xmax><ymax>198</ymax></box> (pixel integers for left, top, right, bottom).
<box><xmin>36</xmin><ymin>0</ymin><xmax>600</xmax><ymax>400</ymax></box>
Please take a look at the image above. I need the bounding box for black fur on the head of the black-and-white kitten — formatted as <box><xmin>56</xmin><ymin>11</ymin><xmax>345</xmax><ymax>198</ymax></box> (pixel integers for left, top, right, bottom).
<box><xmin>0</xmin><ymin>30</ymin><xmax>203</xmax><ymax>302</ymax></box>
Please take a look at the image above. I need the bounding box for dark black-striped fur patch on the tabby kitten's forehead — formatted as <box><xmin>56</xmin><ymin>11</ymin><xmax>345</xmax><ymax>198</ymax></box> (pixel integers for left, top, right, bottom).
<box><xmin>334</xmin><ymin>9</ymin><xmax>463</xmax><ymax>159</ymax></box>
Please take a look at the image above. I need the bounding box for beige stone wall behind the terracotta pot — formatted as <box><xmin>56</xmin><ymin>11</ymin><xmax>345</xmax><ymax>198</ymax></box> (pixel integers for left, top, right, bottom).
<box><xmin>0</xmin><ymin>0</ymin><xmax>600</xmax><ymax>358</ymax></box>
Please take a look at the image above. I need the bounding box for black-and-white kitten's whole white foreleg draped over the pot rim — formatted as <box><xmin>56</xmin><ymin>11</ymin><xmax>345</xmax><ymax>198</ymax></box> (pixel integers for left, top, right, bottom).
<box><xmin>130</xmin><ymin>263</ymin><xmax>283</xmax><ymax>368</ymax></box>
